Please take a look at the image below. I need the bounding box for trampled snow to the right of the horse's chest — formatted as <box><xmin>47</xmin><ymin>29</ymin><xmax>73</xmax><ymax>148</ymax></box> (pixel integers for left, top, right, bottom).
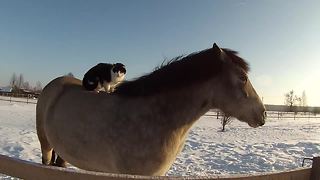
<box><xmin>168</xmin><ymin>116</ymin><xmax>320</xmax><ymax>176</ymax></box>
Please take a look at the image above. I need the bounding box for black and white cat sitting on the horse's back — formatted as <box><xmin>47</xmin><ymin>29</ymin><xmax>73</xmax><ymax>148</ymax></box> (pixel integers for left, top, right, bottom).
<box><xmin>82</xmin><ymin>63</ymin><xmax>127</xmax><ymax>93</ymax></box>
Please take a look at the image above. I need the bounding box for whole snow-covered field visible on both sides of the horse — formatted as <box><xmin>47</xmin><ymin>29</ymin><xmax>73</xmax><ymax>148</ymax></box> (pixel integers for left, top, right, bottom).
<box><xmin>0</xmin><ymin>101</ymin><xmax>320</xmax><ymax>179</ymax></box>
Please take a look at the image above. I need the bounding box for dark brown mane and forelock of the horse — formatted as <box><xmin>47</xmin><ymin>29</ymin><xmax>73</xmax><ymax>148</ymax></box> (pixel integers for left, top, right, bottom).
<box><xmin>114</xmin><ymin>48</ymin><xmax>249</xmax><ymax>96</ymax></box>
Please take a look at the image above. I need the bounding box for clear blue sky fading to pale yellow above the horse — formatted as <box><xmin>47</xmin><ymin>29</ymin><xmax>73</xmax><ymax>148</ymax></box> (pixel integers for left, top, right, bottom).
<box><xmin>0</xmin><ymin>0</ymin><xmax>320</xmax><ymax>106</ymax></box>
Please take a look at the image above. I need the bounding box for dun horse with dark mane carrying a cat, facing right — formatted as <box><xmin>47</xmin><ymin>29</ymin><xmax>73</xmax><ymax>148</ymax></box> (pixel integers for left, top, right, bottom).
<box><xmin>36</xmin><ymin>43</ymin><xmax>265</xmax><ymax>176</ymax></box>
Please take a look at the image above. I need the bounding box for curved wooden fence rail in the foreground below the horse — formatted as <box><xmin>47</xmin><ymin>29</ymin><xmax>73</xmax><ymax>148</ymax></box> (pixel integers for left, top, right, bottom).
<box><xmin>0</xmin><ymin>155</ymin><xmax>320</xmax><ymax>180</ymax></box>
